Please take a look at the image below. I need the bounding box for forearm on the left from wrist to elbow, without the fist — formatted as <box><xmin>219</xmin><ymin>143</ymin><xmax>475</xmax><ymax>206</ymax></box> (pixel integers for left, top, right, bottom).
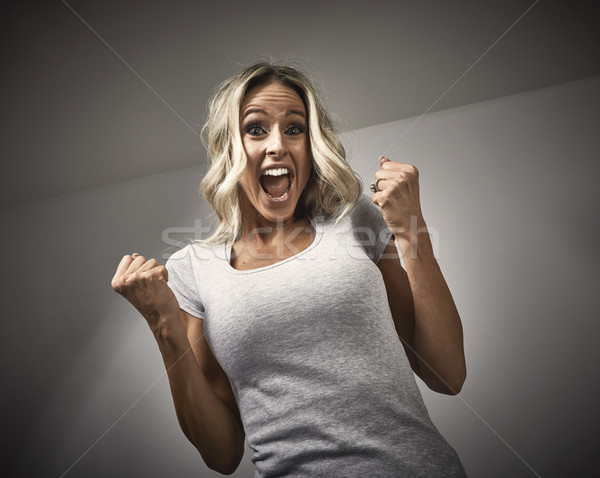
<box><xmin>153</xmin><ymin>317</ymin><xmax>244</xmax><ymax>474</ymax></box>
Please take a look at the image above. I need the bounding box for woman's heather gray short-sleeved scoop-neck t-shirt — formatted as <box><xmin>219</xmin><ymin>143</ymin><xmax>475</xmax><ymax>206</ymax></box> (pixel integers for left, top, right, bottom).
<box><xmin>167</xmin><ymin>196</ymin><xmax>465</xmax><ymax>478</ymax></box>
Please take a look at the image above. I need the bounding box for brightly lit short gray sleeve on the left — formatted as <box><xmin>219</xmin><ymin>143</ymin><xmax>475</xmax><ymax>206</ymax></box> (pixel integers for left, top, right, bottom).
<box><xmin>165</xmin><ymin>246</ymin><xmax>204</xmax><ymax>319</ymax></box>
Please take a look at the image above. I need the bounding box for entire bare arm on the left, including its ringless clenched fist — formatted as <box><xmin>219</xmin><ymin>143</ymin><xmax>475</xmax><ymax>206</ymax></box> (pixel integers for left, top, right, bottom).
<box><xmin>112</xmin><ymin>255</ymin><xmax>244</xmax><ymax>474</ymax></box>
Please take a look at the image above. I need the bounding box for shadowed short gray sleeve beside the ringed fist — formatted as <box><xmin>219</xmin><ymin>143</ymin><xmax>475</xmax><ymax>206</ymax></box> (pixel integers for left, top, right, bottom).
<box><xmin>350</xmin><ymin>194</ymin><xmax>392</xmax><ymax>264</ymax></box>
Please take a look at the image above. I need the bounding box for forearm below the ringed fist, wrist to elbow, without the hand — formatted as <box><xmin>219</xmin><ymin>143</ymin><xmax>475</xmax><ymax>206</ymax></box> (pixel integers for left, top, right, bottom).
<box><xmin>398</xmin><ymin>226</ymin><xmax>466</xmax><ymax>394</ymax></box>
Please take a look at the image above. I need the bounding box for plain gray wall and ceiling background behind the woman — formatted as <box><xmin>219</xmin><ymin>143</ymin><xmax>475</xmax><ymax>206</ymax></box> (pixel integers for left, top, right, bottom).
<box><xmin>0</xmin><ymin>1</ymin><xmax>600</xmax><ymax>477</ymax></box>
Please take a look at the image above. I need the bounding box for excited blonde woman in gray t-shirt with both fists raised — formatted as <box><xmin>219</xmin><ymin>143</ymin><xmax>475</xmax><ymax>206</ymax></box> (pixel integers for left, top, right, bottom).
<box><xmin>112</xmin><ymin>64</ymin><xmax>466</xmax><ymax>477</ymax></box>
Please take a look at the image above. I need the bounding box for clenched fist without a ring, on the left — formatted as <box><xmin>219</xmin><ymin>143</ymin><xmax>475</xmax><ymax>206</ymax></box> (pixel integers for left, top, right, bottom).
<box><xmin>111</xmin><ymin>254</ymin><xmax>179</xmax><ymax>331</ymax></box>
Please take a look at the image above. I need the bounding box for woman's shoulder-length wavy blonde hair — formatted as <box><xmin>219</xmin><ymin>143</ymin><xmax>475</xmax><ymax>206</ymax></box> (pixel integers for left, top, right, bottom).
<box><xmin>200</xmin><ymin>63</ymin><xmax>362</xmax><ymax>244</ymax></box>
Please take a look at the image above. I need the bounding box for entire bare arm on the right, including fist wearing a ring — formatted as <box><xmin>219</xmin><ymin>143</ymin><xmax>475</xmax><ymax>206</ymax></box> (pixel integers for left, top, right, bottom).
<box><xmin>372</xmin><ymin>158</ymin><xmax>466</xmax><ymax>394</ymax></box>
